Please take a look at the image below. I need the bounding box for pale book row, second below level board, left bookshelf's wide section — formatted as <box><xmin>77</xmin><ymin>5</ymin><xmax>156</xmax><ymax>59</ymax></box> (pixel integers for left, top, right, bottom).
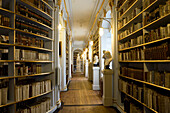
<box><xmin>15</xmin><ymin>79</ymin><xmax>51</xmax><ymax>101</ymax></box>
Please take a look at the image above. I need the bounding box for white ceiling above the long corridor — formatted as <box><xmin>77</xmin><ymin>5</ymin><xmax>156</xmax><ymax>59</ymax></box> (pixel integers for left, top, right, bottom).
<box><xmin>71</xmin><ymin>0</ymin><xmax>101</xmax><ymax>47</ymax></box>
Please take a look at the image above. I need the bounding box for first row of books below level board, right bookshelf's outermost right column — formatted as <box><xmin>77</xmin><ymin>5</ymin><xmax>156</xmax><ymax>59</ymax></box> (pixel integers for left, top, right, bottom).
<box><xmin>145</xmin><ymin>71</ymin><xmax>170</xmax><ymax>88</ymax></box>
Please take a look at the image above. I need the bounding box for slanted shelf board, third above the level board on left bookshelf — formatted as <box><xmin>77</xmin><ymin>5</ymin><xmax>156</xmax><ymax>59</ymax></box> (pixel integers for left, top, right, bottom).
<box><xmin>15</xmin><ymin>13</ymin><xmax>53</xmax><ymax>30</ymax></box>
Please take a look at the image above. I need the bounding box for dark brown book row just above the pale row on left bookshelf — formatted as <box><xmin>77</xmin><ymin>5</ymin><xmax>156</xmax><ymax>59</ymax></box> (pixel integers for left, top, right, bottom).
<box><xmin>15</xmin><ymin>33</ymin><xmax>44</xmax><ymax>48</ymax></box>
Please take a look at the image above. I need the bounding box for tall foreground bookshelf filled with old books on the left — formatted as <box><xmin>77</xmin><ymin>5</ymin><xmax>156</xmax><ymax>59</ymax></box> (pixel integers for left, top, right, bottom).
<box><xmin>0</xmin><ymin>0</ymin><xmax>54</xmax><ymax>113</ymax></box>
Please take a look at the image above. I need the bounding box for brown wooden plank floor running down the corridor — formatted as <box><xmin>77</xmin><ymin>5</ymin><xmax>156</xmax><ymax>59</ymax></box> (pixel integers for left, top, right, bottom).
<box><xmin>59</xmin><ymin>74</ymin><xmax>117</xmax><ymax>113</ymax></box>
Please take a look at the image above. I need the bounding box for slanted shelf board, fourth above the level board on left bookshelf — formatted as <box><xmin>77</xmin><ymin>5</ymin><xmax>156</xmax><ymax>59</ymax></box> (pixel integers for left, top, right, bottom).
<box><xmin>17</xmin><ymin>0</ymin><xmax>53</xmax><ymax>20</ymax></box>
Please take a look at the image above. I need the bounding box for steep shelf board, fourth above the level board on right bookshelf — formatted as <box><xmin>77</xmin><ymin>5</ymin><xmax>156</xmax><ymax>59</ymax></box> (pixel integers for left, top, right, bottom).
<box><xmin>118</xmin><ymin>0</ymin><xmax>142</xmax><ymax>20</ymax></box>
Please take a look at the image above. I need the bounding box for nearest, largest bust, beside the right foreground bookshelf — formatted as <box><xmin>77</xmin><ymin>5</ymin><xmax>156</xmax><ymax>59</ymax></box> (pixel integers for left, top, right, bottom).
<box><xmin>103</xmin><ymin>51</ymin><xmax>112</xmax><ymax>69</ymax></box>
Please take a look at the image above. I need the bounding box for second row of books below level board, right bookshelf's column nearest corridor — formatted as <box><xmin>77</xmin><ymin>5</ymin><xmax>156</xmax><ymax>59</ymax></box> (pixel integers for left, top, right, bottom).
<box><xmin>119</xmin><ymin>79</ymin><xmax>144</xmax><ymax>102</ymax></box>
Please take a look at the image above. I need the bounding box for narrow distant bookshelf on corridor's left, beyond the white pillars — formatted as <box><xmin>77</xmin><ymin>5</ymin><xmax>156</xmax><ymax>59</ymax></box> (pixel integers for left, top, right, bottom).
<box><xmin>66</xmin><ymin>33</ymin><xmax>69</xmax><ymax>83</ymax></box>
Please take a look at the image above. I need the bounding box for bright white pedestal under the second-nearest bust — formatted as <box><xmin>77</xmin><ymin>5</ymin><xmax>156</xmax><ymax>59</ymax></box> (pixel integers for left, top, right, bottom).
<box><xmin>93</xmin><ymin>67</ymin><xmax>100</xmax><ymax>90</ymax></box>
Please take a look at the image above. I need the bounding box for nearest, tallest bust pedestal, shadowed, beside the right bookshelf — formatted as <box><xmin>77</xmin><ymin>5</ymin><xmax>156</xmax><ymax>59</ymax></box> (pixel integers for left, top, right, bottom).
<box><xmin>102</xmin><ymin>69</ymin><xmax>113</xmax><ymax>106</ymax></box>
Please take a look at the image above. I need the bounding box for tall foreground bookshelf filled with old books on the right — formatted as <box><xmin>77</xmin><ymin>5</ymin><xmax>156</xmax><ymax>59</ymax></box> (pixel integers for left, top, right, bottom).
<box><xmin>117</xmin><ymin>0</ymin><xmax>170</xmax><ymax>113</ymax></box>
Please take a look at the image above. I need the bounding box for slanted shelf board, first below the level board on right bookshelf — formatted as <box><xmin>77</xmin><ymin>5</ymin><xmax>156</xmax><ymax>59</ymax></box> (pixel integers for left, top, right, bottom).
<box><xmin>119</xmin><ymin>75</ymin><xmax>170</xmax><ymax>91</ymax></box>
